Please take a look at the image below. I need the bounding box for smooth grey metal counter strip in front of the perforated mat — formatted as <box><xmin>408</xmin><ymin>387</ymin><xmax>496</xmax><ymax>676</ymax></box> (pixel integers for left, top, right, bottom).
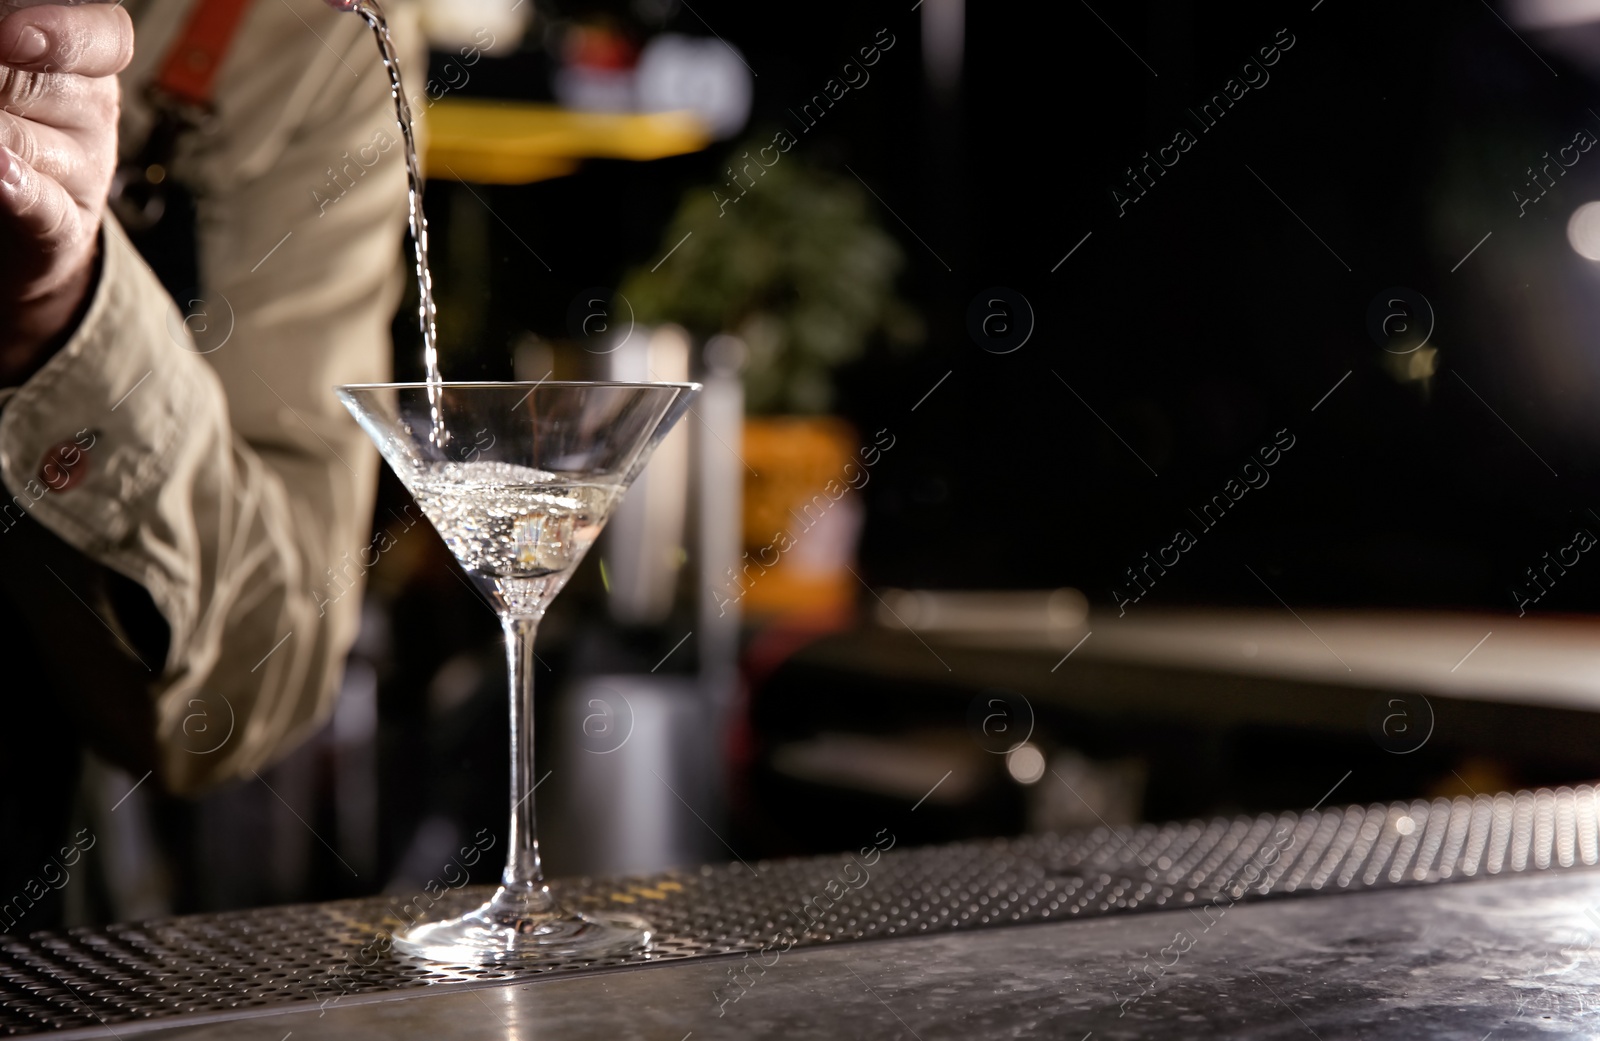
<box><xmin>131</xmin><ymin>871</ymin><xmax>1600</xmax><ymax>1041</ymax></box>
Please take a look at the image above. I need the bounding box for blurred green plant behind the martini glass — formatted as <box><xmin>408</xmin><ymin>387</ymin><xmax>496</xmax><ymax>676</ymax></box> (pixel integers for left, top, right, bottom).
<box><xmin>619</xmin><ymin>136</ymin><xmax>923</xmax><ymax>414</ymax></box>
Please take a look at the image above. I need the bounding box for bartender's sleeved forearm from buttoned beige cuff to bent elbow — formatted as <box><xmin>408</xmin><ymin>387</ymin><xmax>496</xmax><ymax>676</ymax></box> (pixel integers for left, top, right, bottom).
<box><xmin>0</xmin><ymin>215</ymin><xmax>376</xmax><ymax>790</ymax></box>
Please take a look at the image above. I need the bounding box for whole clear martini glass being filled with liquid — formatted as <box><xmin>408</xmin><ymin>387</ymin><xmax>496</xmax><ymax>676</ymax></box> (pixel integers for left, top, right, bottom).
<box><xmin>338</xmin><ymin>382</ymin><xmax>699</xmax><ymax>964</ymax></box>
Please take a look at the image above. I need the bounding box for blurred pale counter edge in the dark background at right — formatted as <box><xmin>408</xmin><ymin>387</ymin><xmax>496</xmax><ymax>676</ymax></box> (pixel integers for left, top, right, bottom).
<box><xmin>814</xmin><ymin>610</ymin><xmax>1600</xmax><ymax>712</ymax></box>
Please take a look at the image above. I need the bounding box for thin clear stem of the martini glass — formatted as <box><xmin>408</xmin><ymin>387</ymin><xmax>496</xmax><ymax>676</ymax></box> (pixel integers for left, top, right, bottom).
<box><xmin>496</xmin><ymin>616</ymin><xmax>555</xmax><ymax>913</ymax></box>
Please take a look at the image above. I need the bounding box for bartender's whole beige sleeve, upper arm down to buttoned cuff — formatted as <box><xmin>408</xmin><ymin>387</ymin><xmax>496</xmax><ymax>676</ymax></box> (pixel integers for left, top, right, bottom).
<box><xmin>0</xmin><ymin>0</ymin><xmax>424</xmax><ymax>792</ymax></box>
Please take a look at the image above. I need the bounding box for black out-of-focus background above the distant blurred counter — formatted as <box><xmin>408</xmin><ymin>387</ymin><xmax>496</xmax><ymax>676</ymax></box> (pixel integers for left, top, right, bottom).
<box><xmin>416</xmin><ymin>0</ymin><xmax>1600</xmax><ymax>611</ymax></box>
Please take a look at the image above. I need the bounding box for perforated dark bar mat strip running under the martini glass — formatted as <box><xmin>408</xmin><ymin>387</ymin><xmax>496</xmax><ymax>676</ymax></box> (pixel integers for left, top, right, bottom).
<box><xmin>0</xmin><ymin>785</ymin><xmax>1600</xmax><ymax>1035</ymax></box>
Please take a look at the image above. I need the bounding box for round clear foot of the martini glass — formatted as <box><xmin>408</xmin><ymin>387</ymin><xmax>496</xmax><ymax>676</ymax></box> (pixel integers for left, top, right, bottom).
<box><xmin>394</xmin><ymin>886</ymin><xmax>654</xmax><ymax>966</ymax></box>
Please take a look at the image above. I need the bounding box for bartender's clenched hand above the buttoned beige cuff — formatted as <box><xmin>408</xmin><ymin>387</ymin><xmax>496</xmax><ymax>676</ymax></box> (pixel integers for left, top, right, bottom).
<box><xmin>0</xmin><ymin>3</ymin><xmax>133</xmax><ymax>387</ymax></box>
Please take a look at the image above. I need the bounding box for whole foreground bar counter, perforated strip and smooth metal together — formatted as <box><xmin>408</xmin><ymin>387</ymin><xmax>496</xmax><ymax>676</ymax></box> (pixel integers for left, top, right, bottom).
<box><xmin>9</xmin><ymin>787</ymin><xmax>1600</xmax><ymax>1041</ymax></box>
